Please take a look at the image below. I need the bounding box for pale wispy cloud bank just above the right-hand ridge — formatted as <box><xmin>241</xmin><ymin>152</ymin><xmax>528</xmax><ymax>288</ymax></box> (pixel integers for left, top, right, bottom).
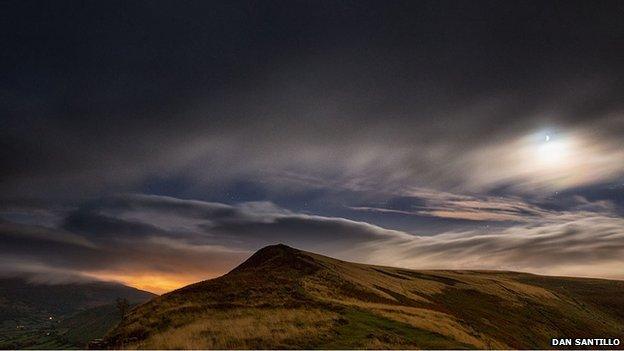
<box><xmin>367</xmin><ymin>213</ymin><xmax>624</xmax><ymax>279</ymax></box>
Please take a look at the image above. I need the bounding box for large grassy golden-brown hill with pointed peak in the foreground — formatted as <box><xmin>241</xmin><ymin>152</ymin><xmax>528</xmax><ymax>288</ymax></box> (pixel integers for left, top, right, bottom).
<box><xmin>107</xmin><ymin>245</ymin><xmax>624</xmax><ymax>349</ymax></box>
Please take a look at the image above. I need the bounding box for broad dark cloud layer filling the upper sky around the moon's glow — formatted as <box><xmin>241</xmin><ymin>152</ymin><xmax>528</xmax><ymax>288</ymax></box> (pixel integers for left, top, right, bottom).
<box><xmin>0</xmin><ymin>1</ymin><xmax>624</xmax><ymax>198</ymax></box>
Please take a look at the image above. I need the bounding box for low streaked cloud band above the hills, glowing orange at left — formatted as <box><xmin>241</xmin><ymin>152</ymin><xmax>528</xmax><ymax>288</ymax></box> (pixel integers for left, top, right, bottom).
<box><xmin>0</xmin><ymin>191</ymin><xmax>624</xmax><ymax>292</ymax></box>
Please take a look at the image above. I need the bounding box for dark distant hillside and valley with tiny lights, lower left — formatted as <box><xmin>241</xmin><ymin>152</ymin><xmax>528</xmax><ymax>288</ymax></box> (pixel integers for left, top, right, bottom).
<box><xmin>0</xmin><ymin>278</ymin><xmax>155</xmax><ymax>349</ymax></box>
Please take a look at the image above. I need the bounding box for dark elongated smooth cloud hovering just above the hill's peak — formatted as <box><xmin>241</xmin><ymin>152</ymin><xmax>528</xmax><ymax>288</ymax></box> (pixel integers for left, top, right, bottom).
<box><xmin>63</xmin><ymin>194</ymin><xmax>398</xmax><ymax>252</ymax></box>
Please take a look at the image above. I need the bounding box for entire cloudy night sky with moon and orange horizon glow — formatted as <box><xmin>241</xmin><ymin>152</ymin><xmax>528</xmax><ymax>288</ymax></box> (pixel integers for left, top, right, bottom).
<box><xmin>0</xmin><ymin>0</ymin><xmax>624</xmax><ymax>292</ymax></box>
